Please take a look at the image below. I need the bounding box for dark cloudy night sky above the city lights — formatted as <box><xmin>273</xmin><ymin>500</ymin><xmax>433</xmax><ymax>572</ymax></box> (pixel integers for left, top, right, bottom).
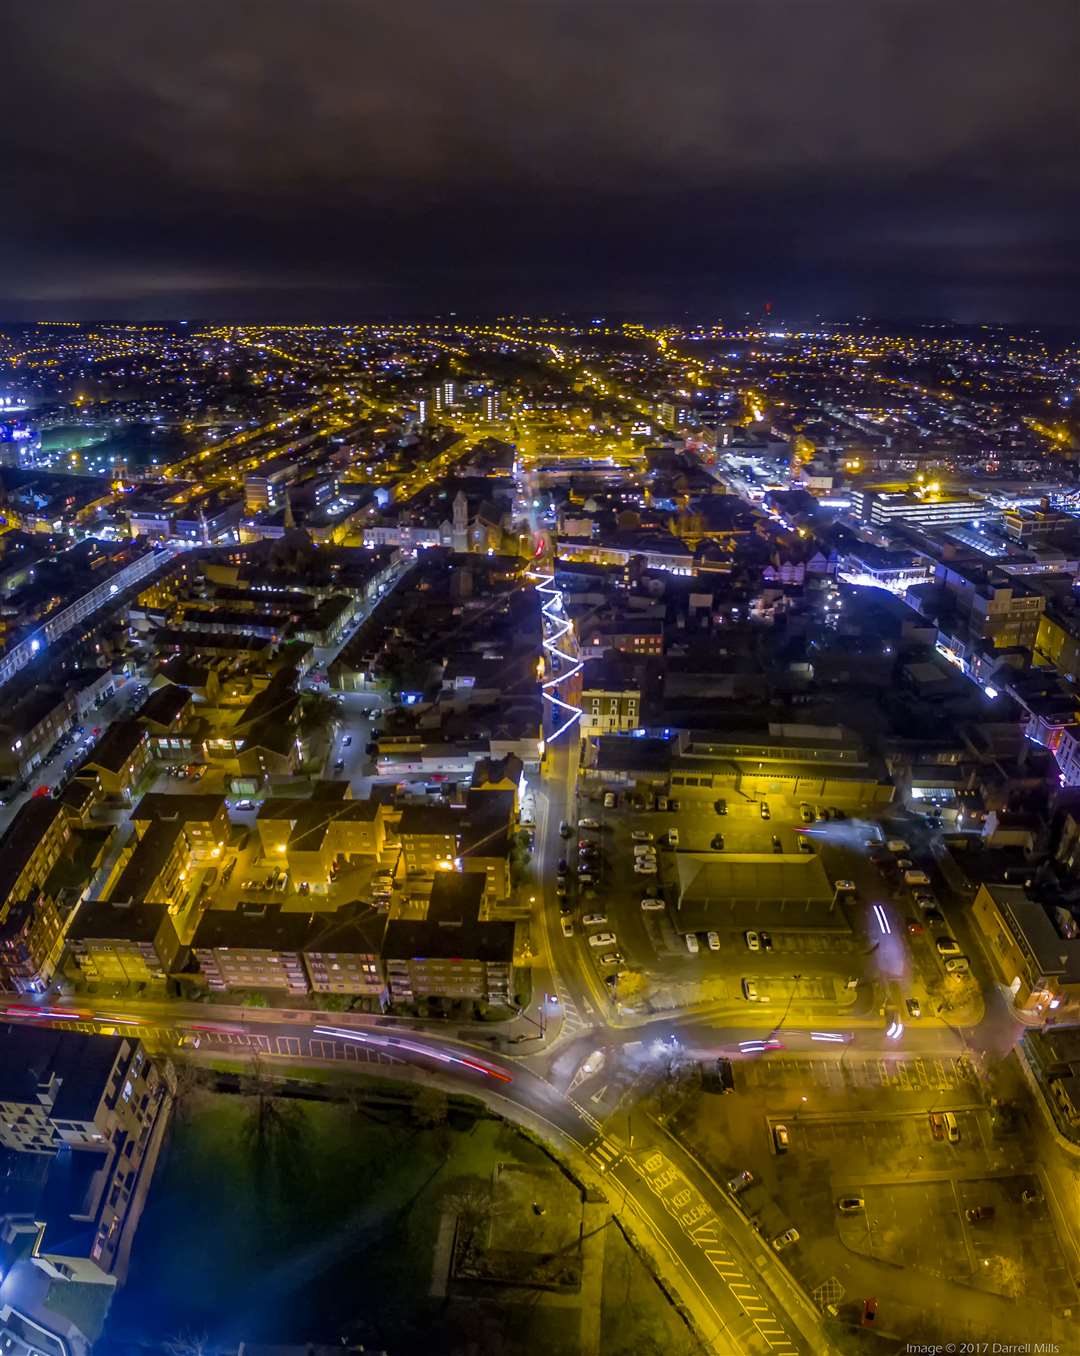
<box><xmin>0</xmin><ymin>0</ymin><xmax>1080</xmax><ymax>324</ymax></box>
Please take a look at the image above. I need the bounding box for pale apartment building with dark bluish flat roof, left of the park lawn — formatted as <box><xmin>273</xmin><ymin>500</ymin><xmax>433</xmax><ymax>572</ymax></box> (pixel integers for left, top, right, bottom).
<box><xmin>0</xmin><ymin>1022</ymin><xmax>170</xmax><ymax>1284</ymax></box>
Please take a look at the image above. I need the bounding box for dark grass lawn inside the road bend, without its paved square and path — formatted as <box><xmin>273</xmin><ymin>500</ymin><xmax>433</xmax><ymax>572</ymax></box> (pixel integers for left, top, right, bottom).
<box><xmin>99</xmin><ymin>1089</ymin><xmax>691</xmax><ymax>1356</ymax></box>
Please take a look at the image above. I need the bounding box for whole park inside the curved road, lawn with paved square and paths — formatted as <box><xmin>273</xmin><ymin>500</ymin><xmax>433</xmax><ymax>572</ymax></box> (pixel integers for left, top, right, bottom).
<box><xmin>103</xmin><ymin>1082</ymin><xmax>696</xmax><ymax>1356</ymax></box>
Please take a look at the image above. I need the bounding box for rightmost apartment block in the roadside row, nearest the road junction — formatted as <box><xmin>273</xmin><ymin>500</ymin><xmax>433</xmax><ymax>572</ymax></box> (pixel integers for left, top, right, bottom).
<box><xmin>383</xmin><ymin>871</ymin><xmax>514</xmax><ymax>1003</ymax></box>
